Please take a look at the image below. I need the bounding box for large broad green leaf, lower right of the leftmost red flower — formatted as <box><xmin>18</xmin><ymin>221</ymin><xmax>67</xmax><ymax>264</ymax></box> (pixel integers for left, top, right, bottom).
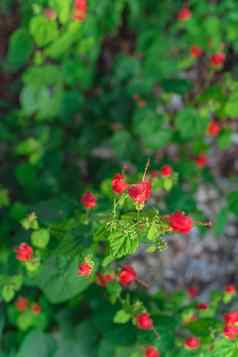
<box><xmin>34</xmin><ymin>257</ymin><xmax>94</xmax><ymax>304</ymax></box>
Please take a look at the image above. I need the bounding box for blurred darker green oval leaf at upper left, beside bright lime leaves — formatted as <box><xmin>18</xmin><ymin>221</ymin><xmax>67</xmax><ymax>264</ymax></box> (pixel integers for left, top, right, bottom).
<box><xmin>7</xmin><ymin>28</ymin><xmax>33</xmax><ymax>71</ymax></box>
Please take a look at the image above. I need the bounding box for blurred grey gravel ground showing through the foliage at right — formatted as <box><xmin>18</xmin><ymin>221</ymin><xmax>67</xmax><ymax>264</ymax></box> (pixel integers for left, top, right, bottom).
<box><xmin>132</xmin><ymin>182</ymin><xmax>238</xmax><ymax>299</ymax></box>
